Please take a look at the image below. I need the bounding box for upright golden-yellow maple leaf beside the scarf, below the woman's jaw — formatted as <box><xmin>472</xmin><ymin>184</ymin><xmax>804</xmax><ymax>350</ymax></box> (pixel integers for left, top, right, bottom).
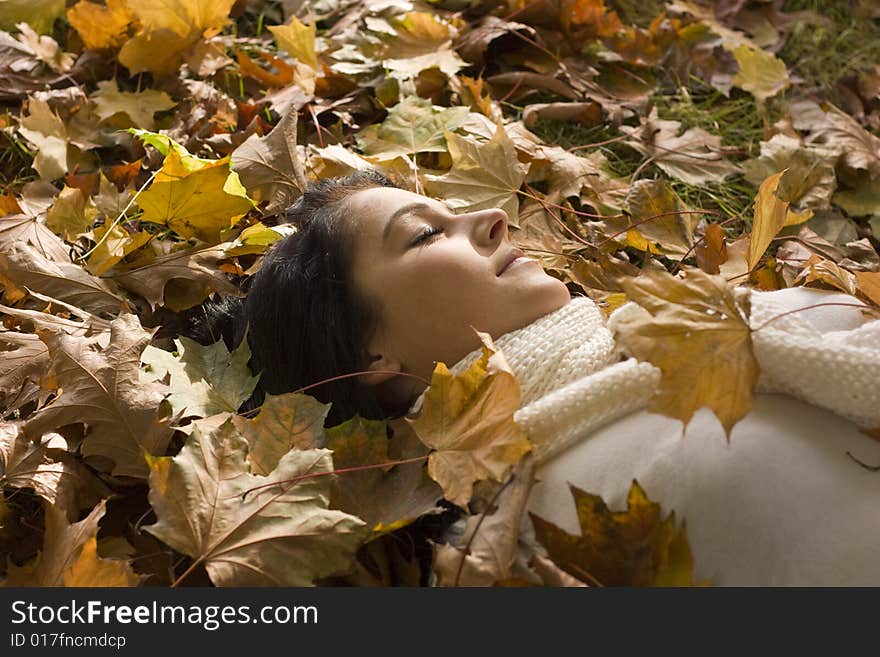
<box><xmin>407</xmin><ymin>331</ymin><xmax>532</xmax><ymax>506</ymax></box>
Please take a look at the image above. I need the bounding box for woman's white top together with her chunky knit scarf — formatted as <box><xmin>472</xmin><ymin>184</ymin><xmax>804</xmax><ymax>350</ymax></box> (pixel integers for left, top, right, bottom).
<box><xmin>413</xmin><ymin>288</ymin><xmax>880</xmax><ymax>585</ymax></box>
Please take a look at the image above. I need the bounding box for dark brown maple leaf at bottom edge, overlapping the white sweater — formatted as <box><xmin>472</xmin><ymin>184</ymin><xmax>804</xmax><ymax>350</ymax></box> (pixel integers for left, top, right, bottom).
<box><xmin>529</xmin><ymin>479</ymin><xmax>693</xmax><ymax>586</ymax></box>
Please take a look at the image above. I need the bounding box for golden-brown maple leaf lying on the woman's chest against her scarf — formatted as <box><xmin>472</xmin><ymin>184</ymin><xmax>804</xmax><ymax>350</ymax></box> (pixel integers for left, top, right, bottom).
<box><xmin>615</xmin><ymin>269</ymin><xmax>758</xmax><ymax>440</ymax></box>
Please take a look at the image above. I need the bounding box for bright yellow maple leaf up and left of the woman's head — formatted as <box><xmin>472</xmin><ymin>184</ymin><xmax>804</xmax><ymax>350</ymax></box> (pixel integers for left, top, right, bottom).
<box><xmin>137</xmin><ymin>148</ymin><xmax>254</xmax><ymax>242</ymax></box>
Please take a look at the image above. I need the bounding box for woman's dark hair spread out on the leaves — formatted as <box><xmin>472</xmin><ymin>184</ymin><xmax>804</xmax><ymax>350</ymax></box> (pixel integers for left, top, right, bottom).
<box><xmin>187</xmin><ymin>171</ymin><xmax>396</xmax><ymax>426</ymax></box>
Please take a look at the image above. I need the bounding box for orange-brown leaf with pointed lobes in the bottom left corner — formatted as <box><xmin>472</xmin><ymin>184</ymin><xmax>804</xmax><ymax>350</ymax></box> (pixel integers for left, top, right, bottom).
<box><xmin>4</xmin><ymin>501</ymin><xmax>140</xmax><ymax>587</ymax></box>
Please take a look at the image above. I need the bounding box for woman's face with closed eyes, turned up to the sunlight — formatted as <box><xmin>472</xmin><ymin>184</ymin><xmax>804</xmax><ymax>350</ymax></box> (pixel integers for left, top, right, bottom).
<box><xmin>349</xmin><ymin>187</ymin><xmax>571</xmax><ymax>388</ymax></box>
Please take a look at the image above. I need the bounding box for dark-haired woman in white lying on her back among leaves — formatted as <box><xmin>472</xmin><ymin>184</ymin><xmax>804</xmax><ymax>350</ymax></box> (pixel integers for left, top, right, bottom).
<box><xmin>194</xmin><ymin>173</ymin><xmax>880</xmax><ymax>585</ymax></box>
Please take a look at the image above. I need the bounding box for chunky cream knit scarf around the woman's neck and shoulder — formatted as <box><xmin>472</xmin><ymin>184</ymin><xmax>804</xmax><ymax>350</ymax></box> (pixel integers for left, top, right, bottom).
<box><xmin>410</xmin><ymin>288</ymin><xmax>880</xmax><ymax>462</ymax></box>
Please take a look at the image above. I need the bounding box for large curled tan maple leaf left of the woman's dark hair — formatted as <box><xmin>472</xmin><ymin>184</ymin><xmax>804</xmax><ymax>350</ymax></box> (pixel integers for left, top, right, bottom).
<box><xmin>24</xmin><ymin>314</ymin><xmax>171</xmax><ymax>478</ymax></box>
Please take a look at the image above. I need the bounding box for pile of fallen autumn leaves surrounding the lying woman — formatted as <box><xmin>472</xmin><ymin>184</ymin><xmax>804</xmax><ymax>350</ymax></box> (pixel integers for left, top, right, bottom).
<box><xmin>0</xmin><ymin>0</ymin><xmax>880</xmax><ymax>586</ymax></box>
